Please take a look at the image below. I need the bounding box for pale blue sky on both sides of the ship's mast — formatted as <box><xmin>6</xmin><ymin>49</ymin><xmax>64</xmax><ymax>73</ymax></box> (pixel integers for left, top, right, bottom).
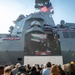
<box><xmin>0</xmin><ymin>0</ymin><xmax>75</xmax><ymax>34</ymax></box>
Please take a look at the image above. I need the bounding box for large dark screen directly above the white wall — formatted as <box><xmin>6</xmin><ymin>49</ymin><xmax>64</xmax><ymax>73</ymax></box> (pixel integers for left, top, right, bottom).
<box><xmin>24</xmin><ymin>33</ymin><xmax>61</xmax><ymax>56</ymax></box>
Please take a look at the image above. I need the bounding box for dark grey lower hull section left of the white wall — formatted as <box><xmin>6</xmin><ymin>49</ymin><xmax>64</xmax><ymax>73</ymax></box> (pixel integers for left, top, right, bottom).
<box><xmin>0</xmin><ymin>51</ymin><xmax>24</xmax><ymax>65</ymax></box>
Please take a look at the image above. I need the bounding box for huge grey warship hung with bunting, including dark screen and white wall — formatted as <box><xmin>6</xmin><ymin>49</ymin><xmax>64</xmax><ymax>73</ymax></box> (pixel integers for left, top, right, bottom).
<box><xmin>0</xmin><ymin>0</ymin><xmax>75</xmax><ymax>64</ymax></box>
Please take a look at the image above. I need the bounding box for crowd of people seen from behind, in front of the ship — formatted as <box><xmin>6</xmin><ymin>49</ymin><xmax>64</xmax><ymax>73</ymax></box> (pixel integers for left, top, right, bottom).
<box><xmin>2</xmin><ymin>62</ymin><xmax>75</xmax><ymax>75</ymax></box>
